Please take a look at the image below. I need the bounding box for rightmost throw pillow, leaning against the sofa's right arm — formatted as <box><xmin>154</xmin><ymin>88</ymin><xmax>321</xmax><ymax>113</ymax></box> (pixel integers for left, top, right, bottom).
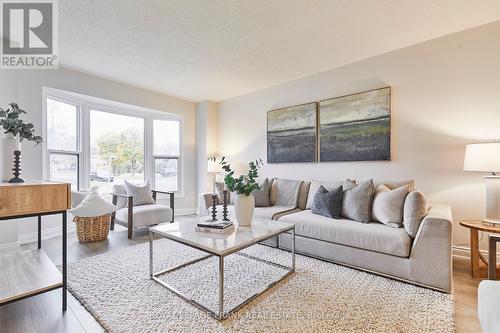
<box><xmin>403</xmin><ymin>191</ymin><xmax>429</xmax><ymax>238</ymax></box>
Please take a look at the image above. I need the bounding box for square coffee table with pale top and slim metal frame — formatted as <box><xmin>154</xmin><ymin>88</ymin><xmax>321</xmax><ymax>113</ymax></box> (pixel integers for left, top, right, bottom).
<box><xmin>149</xmin><ymin>218</ymin><xmax>295</xmax><ymax>321</ymax></box>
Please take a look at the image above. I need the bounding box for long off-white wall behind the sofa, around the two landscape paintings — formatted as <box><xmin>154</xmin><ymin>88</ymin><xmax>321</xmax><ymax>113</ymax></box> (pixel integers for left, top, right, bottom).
<box><xmin>219</xmin><ymin>22</ymin><xmax>500</xmax><ymax>252</ymax></box>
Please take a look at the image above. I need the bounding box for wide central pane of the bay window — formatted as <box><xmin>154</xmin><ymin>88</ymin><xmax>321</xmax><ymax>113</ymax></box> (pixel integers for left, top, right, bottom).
<box><xmin>90</xmin><ymin>110</ymin><xmax>144</xmax><ymax>193</ymax></box>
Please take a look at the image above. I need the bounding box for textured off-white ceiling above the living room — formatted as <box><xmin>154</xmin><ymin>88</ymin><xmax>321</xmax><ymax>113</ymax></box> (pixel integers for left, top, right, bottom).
<box><xmin>59</xmin><ymin>0</ymin><xmax>500</xmax><ymax>101</ymax></box>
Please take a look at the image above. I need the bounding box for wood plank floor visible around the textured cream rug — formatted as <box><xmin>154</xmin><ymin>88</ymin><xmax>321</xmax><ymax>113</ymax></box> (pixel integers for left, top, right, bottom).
<box><xmin>0</xmin><ymin>217</ymin><xmax>481</xmax><ymax>333</ymax></box>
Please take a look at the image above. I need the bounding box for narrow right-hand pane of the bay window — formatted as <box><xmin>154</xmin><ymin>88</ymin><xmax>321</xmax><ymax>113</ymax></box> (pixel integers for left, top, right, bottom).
<box><xmin>153</xmin><ymin>120</ymin><xmax>180</xmax><ymax>191</ymax></box>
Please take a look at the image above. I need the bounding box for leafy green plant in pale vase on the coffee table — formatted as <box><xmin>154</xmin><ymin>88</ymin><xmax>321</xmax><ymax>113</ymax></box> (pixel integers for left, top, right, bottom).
<box><xmin>220</xmin><ymin>156</ymin><xmax>263</xmax><ymax>227</ymax></box>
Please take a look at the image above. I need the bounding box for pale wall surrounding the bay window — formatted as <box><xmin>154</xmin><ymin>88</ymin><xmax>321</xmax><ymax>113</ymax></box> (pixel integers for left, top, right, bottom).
<box><xmin>0</xmin><ymin>68</ymin><xmax>196</xmax><ymax>248</ymax></box>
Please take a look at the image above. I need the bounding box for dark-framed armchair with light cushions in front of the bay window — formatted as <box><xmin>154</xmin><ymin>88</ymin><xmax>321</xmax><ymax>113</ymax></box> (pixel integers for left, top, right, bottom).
<box><xmin>110</xmin><ymin>184</ymin><xmax>174</xmax><ymax>239</ymax></box>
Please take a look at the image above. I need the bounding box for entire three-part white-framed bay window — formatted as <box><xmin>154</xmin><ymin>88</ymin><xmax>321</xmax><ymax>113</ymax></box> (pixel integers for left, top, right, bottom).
<box><xmin>43</xmin><ymin>88</ymin><xmax>183</xmax><ymax>197</ymax></box>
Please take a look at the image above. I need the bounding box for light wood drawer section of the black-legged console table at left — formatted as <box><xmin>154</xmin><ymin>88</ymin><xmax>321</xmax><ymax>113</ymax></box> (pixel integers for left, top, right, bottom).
<box><xmin>0</xmin><ymin>182</ymin><xmax>71</xmax><ymax>217</ymax></box>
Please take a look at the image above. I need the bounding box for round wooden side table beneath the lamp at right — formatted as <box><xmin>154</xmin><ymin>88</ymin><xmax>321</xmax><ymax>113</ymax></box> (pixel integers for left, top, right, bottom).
<box><xmin>460</xmin><ymin>220</ymin><xmax>500</xmax><ymax>278</ymax></box>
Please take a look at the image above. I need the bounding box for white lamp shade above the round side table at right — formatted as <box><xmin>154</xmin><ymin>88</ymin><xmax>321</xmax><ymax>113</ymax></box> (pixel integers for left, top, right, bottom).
<box><xmin>464</xmin><ymin>142</ymin><xmax>500</xmax><ymax>172</ymax></box>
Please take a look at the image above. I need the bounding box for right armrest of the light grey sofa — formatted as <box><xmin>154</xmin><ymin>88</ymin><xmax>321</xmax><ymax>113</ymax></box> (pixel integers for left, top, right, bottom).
<box><xmin>410</xmin><ymin>205</ymin><xmax>453</xmax><ymax>292</ymax></box>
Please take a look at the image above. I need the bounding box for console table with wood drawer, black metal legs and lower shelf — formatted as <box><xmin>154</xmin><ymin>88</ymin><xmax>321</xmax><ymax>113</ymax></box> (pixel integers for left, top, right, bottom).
<box><xmin>0</xmin><ymin>182</ymin><xmax>71</xmax><ymax>311</ymax></box>
